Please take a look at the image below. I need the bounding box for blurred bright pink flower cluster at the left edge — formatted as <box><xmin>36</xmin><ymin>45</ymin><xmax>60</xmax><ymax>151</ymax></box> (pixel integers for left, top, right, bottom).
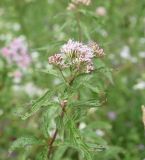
<box><xmin>1</xmin><ymin>37</ymin><xmax>31</xmax><ymax>69</ymax></box>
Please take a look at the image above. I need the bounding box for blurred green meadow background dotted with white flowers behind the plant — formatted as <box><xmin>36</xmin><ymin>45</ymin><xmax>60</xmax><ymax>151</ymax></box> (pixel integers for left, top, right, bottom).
<box><xmin>0</xmin><ymin>0</ymin><xmax>145</xmax><ymax>160</ymax></box>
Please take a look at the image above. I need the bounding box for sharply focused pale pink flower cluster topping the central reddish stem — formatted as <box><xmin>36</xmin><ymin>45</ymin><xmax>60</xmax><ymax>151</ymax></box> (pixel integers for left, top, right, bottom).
<box><xmin>49</xmin><ymin>40</ymin><xmax>104</xmax><ymax>73</ymax></box>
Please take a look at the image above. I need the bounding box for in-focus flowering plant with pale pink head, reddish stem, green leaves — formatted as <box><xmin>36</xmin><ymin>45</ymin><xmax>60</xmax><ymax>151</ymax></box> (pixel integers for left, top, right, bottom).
<box><xmin>11</xmin><ymin>40</ymin><xmax>111</xmax><ymax>160</ymax></box>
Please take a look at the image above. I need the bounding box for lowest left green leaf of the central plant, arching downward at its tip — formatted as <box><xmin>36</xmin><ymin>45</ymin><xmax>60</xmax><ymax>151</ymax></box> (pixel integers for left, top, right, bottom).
<box><xmin>10</xmin><ymin>136</ymin><xmax>43</xmax><ymax>152</ymax></box>
